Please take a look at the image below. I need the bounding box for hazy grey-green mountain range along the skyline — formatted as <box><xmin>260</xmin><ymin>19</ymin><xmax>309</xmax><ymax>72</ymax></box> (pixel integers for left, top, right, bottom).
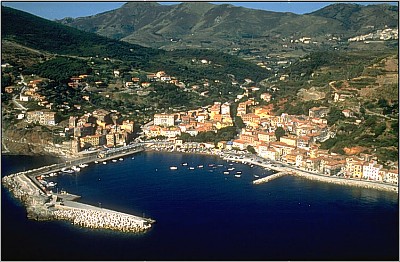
<box><xmin>59</xmin><ymin>2</ymin><xmax>398</xmax><ymax>49</ymax></box>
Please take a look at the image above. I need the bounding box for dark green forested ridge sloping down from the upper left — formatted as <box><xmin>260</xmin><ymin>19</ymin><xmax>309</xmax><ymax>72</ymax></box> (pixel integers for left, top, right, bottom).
<box><xmin>1</xmin><ymin>6</ymin><xmax>268</xmax><ymax>81</ymax></box>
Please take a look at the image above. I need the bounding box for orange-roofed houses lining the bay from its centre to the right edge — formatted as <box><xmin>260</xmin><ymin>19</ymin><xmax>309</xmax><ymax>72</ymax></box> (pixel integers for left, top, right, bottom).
<box><xmin>143</xmin><ymin>94</ymin><xmax>398</xmax><ymax>184</ymax></box>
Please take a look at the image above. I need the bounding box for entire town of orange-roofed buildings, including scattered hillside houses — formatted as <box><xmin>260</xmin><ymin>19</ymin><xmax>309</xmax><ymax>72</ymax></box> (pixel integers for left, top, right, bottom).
<box><xmin>6</xmin><ymin>65</ymin><xmax>398</xmax><ymax>185</ymax></box>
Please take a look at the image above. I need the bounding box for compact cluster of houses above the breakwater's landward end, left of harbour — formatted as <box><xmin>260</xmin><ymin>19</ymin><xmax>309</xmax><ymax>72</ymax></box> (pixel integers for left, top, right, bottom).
<box><xmin>65</xmin><ymin>109</ymin><xmax>134</xmax><ymax>153</ymax></box>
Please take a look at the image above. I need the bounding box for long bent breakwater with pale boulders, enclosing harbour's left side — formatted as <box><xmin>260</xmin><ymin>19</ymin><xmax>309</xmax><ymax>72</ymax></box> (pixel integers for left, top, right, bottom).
<box><xmin>2</xmin><ymin>145</ymin><xmax>155</xmax><ymax>233</ymax></box>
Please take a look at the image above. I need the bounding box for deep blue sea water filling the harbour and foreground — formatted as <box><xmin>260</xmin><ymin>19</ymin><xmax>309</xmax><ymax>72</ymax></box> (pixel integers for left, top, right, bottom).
<box><xmin>1</xmin><ymin>152</ymin><xmax>399</xmax><ymax>260</ymax></box>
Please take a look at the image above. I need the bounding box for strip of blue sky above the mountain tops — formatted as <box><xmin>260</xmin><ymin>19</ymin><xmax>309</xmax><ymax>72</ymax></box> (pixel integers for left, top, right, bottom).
<box><xmin>1</xmin><ymin>0</ymin><xmax>398</xmax><ymax>20</ymax></box>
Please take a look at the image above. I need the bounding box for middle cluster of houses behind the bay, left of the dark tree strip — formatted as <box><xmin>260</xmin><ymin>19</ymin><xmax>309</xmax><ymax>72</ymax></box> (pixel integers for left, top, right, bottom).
<box><xmin>143</xmin><ymin>102</ymin><xmax>233</xmax><ymax>138</ymax></box>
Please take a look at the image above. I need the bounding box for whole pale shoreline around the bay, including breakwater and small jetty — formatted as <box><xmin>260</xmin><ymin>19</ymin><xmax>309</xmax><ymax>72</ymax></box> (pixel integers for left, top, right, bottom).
<box><xmin>2</xmin><ymin>147</ymin><xmax>398</xmax><ymax>233</ymax></box>
